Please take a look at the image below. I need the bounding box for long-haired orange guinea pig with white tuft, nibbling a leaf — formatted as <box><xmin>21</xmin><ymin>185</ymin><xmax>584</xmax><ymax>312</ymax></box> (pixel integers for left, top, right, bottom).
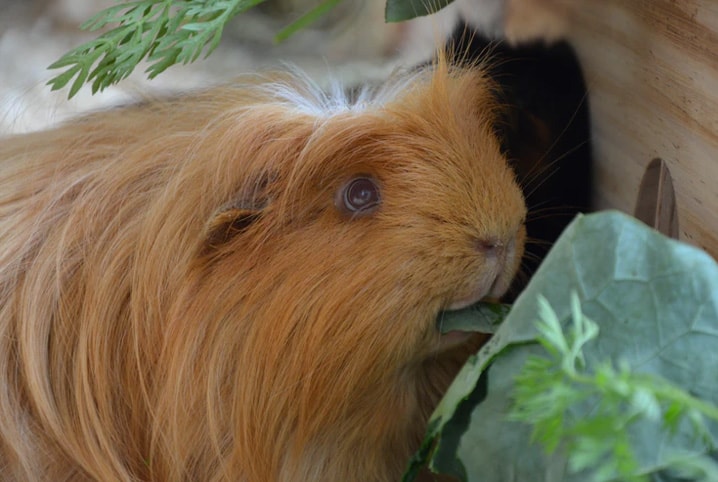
<box><xmin>0</xmin><ymin>60</ymin><xmax>526</xmax><ymax>482</ymax></box>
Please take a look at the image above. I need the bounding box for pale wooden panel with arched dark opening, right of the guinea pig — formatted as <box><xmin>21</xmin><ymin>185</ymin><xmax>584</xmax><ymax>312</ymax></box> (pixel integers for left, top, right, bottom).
<box><xmin>506</xmin><ymin>0</ymin><xmax>718</xmax><ymax>258</ymax></box>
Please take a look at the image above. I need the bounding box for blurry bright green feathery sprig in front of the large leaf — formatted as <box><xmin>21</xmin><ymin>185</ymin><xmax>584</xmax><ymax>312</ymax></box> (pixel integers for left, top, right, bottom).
<box><xmin>509</xmin><ymin>294</ymin><xmax>718</xmax><ymax>482</ymax></box>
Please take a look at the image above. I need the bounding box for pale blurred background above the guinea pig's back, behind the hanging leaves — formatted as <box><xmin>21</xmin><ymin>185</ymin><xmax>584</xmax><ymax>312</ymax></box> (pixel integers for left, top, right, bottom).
<box><xmin>0</xmin><ymin>0</ymin><xmax>462</xmax><ymax>135</ymax></box>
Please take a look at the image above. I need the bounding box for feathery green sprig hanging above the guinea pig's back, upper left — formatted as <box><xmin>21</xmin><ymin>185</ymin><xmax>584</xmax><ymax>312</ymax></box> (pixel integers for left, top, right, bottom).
<box><xmin>48</xmin><ymin>0</ymin><xmax>264</xmax><ymax>97</ymax></box>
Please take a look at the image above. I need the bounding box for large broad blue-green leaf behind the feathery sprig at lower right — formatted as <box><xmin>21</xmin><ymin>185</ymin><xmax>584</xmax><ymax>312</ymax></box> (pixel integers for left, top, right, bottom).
<box><xmin>406</xmin><ymin>211</ymin><xmax>718</xmax><ymax>482</ymax></box>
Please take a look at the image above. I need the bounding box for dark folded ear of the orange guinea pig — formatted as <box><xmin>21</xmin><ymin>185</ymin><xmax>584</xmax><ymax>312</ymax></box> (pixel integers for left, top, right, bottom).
<box><xmin>205</xmin><ymin>179</ymin><xmax>270</xmax><ymax>250</ymax></box>
